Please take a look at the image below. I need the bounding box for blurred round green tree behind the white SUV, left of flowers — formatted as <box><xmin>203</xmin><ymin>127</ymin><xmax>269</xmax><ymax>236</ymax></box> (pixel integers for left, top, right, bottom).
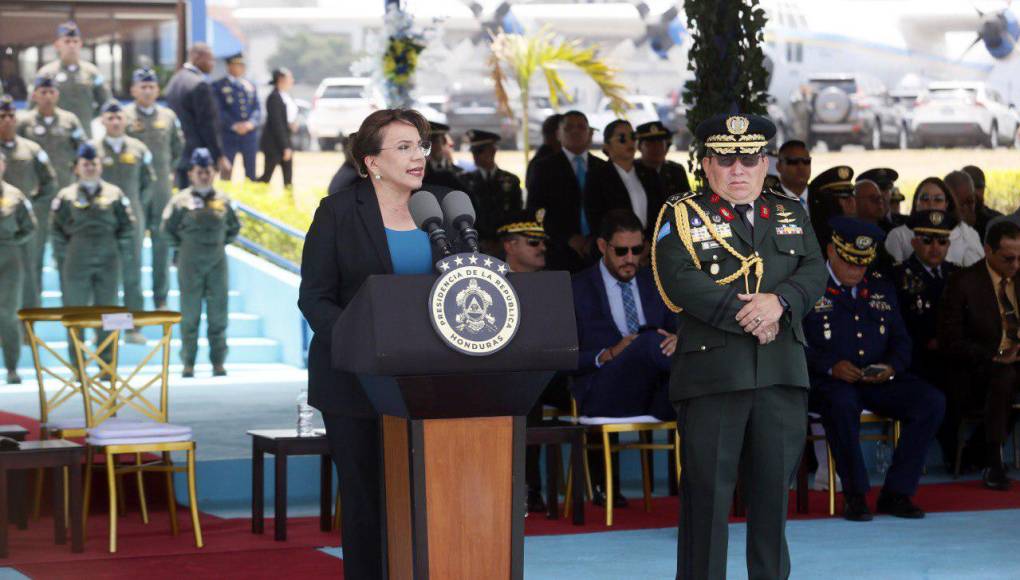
<box><xmin>266</xmin><ymin>31</ymin><xmax>359</xmax><ymax>84</ymax></box>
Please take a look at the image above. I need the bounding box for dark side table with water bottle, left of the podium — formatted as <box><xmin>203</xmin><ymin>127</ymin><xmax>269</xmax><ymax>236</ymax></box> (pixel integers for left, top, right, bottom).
<box><xmin>248</xmin><ymin>429</ymin><xmax>333</xmax><ymax>541</ymax></box>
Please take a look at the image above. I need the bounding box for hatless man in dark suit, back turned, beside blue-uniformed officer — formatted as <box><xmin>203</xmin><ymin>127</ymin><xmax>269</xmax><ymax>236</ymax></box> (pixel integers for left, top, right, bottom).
<box><xmin>165</xmin><ymin>43</ymin><xmax>231</xmax><ymax>189</ymax></box>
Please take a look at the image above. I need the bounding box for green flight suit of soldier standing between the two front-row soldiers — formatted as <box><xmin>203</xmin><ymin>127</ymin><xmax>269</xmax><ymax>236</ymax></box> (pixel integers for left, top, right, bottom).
<box><xmin>93</xmin><ymin>136</ymin><xmax>156</xmax><ymax>310</ymax></box>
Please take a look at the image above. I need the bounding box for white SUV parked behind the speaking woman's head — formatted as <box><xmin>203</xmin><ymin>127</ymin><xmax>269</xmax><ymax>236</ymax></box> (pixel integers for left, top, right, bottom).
<box><xmin>308</xmin><ymin>76</ymin><xmax>386</xmax><ymax>151</ymax></box>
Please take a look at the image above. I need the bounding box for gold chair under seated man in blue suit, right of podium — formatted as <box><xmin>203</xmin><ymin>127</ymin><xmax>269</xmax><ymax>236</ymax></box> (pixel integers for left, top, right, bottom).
<box><xmin>563</xmin><ymin>398</ymin><xmax>680</xmax><ymax>527</ymax></box>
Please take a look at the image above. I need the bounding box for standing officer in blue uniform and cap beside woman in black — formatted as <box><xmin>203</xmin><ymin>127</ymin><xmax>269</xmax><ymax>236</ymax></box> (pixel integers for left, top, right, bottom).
<box><xmin>212</xmin><ymin>53</ymin><xmax>262</xmax><ymax>181</ymax></box>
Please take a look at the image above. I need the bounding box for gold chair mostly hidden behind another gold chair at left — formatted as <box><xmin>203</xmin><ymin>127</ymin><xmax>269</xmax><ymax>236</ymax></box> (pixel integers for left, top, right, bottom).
<box><xmin>17</xmin><ymin>306</ymin><xmax>126</xmax><ymax>520</ymax></box>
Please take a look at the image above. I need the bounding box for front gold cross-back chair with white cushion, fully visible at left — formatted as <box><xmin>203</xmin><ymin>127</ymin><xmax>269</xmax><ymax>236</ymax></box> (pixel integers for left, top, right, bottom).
<box><xmin>62</xmin><ymin>312</ymin><xmax>203</xmax><ymax>552</ymax></box>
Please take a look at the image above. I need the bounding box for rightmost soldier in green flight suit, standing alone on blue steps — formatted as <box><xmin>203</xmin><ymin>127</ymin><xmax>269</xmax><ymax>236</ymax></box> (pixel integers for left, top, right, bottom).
<box><xmin>163</xmin><ymin>148</ymin><xmax>241</xmax><ymax>378</ymax></box>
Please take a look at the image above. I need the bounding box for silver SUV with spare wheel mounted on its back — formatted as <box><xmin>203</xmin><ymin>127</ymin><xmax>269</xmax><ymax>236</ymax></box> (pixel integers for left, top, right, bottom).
<box><xmin>808</xmin><ymin>73</ymin><xmax>910</xmax><ymax>151</ymax></box>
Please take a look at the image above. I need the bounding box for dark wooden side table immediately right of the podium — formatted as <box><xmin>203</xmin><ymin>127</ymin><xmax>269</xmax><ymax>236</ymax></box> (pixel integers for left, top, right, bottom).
<box><xmin>525</xmin><ymin>421</ymin><xmax>584</xmax><ymax>526</ymax></box>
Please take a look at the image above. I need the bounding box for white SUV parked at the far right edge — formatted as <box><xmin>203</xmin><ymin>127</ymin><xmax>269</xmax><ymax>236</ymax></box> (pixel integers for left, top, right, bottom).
<box><xmin>911</xmin><ymin>82</ymin><xmax>1017</xmax><ymax>149</ymax></box>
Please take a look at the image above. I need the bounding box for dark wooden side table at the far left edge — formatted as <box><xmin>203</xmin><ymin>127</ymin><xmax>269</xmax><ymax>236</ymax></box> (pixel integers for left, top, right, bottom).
<box><xmin>0</xmin><ymin>439</ymin><xmax>85</xmax><ymax>558</ymax></box>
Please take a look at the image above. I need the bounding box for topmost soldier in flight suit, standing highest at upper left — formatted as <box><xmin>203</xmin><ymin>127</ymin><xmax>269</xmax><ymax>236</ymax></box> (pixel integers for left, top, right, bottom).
<box><xmin>39</xmin><ymin>21</ymin><xmax>110</xmax><ymax>137</ymax></box>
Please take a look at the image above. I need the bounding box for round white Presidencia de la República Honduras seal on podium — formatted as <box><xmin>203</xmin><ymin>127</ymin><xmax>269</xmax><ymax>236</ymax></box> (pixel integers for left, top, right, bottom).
<box><xmin>428</xmin><ymin>254</ymin><xmax>520</xmax><ymax>357</ymax></box>
